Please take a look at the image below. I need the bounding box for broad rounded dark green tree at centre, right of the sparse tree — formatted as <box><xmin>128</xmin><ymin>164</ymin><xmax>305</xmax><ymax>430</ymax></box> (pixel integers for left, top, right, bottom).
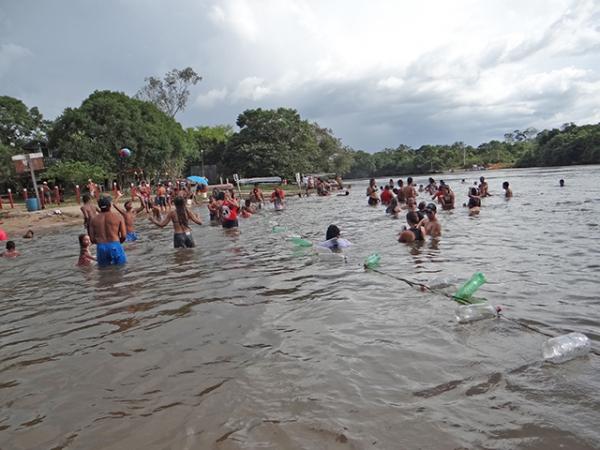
<box><xmin>223</xmin><ymin>108</ymin><xmax>319</xmax><ymax>179</ymax></box>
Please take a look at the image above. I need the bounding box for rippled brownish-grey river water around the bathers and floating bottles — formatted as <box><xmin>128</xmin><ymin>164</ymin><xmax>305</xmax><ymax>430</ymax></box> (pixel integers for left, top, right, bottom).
<box><xmin>0</xmin><ymin>166</ymin><xmax>600</xmax><ymax>450</ymax></box>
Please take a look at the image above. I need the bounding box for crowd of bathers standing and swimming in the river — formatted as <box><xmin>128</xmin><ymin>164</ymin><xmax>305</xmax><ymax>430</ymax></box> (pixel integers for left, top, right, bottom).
<box><xmin>0</xmin><ymin>172</ymin><xmax>564</xmax><ymax>267</ymax></box>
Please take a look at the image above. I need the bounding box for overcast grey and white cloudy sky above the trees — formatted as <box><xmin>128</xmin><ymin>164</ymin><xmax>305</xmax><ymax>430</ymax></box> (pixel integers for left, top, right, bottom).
<box><xmin>0</xmin><ymin>0</ymin><xmax>600</xmax><ymax>153</ymax></box>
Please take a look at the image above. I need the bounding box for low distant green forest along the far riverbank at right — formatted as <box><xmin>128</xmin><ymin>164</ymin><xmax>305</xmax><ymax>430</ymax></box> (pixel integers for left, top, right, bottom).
<box><xmin>346</xmin><ymin>123</ymin><xmax>600</xmax><ymax>178</ymax></box>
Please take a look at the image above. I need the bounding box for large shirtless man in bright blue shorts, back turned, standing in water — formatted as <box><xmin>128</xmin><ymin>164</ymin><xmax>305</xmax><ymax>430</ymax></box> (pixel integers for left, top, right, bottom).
<box><xmin>89</xmin><ymin>197</ymin><xmax>127</xmax><ymax>267</ymax></box>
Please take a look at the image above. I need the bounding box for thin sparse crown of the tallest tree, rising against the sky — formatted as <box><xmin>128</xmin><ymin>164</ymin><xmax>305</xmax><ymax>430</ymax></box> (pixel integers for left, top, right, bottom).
<box><xmin>134</xmin><ymin>67</ymin><xmax>202</xmax><ymax>117</ymax></box>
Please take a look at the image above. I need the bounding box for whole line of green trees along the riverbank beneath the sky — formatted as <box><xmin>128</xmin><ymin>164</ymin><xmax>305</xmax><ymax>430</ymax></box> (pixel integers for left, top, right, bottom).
<box><xmin>0</xmin><ymin>68</ymin><xmax>600</xmax><ymax>192</ymax></box>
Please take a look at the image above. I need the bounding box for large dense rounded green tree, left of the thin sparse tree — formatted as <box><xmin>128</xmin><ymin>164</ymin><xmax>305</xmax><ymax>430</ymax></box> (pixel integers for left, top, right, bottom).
<box><xmin>49</xmin><ymin>91</ymin><xmax>191</xmax><ymax>181</ymax></box>
